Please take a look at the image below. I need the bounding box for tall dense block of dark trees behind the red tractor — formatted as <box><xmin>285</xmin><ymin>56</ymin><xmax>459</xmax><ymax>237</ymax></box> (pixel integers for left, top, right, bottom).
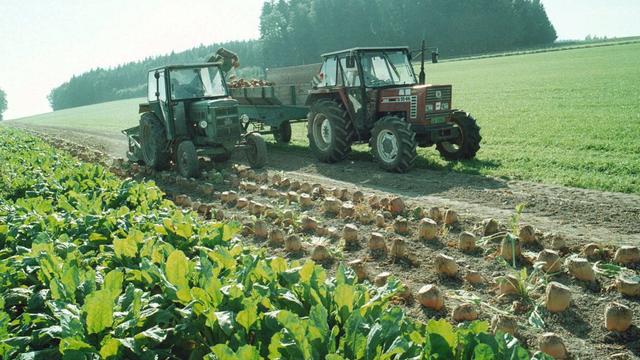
<box><xmin>260</xmin><ymin>0</ymin><xmax>556</xmax><ymax>66</ymax></box>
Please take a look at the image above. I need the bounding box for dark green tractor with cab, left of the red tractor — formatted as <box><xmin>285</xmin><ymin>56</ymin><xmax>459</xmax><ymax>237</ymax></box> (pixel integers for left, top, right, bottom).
<box><xmin>123</xmin><ymin>63</ymin><xmax>267</xmax><ymax>177</ymax></box>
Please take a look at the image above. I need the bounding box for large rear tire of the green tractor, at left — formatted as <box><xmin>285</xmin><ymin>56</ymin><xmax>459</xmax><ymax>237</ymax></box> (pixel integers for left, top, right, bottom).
<box><xmin>140</xmin><ymin>112</ymin><xmax>169</xmax><ymax>170</ymax></box>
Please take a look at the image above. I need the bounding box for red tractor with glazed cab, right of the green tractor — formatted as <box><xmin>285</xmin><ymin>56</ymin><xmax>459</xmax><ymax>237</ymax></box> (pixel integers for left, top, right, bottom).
<box><xmin>307</xmin><ymin>47</ymin><xmax>481</xmax><ymax>172</ymax></box>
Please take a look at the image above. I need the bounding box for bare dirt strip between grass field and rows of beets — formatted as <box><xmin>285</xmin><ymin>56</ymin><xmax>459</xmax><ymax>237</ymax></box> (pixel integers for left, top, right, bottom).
<box><xmin>9</xmin><ymin>122</ymin><xmax>640</xmax><ymax>245</ymax></box>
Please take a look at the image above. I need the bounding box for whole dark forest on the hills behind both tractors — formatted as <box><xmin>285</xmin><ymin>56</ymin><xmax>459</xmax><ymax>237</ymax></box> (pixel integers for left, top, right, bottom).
<box><xmin>49</xmin><ymin>0</ymin><xmax>556</xmax><ymax>110</ymax></box>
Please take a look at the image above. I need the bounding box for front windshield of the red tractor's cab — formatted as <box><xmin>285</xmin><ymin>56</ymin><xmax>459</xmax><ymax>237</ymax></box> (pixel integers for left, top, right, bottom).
<box><xmin>360</xmin><ymin>51</ymin><xmax>416</xmax><ymax>87</ymax></box>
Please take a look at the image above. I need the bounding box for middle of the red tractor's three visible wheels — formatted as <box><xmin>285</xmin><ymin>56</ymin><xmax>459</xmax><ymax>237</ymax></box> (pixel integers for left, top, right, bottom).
<box><xmin>371</xmin><ymin>116</ymin><xmax>417</xmax><ymax>173</ymax></box>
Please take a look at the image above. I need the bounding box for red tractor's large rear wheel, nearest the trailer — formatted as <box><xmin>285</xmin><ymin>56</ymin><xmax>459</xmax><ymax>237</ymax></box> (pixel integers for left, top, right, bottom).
<box><xmin>307</xmin><ymin>99</ymin><xmax>353</xmax><ymax>163</ymax></box>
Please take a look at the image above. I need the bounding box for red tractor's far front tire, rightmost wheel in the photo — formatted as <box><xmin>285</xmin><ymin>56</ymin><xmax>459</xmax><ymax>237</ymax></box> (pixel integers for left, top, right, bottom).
<box><xmin>436</xmin><ymin>112</ymin><xmax>482</xmax><ymax>161</ymax></box>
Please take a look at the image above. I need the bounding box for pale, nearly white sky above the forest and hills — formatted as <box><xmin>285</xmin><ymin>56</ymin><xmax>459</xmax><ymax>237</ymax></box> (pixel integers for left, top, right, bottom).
<box><xmin>0</xmin><ymin>0</ymin><xmax>640</xmax><ymax>119</ymax></box>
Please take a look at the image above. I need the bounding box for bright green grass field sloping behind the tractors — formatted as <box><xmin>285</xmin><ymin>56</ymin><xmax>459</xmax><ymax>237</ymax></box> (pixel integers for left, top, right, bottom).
<box><xmin>6</xmin><ymin>43</ymin><xmax>640</xmax><ymax>193</ymax></box>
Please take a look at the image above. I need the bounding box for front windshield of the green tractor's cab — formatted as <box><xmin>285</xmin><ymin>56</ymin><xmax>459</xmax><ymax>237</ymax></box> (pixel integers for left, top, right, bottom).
<box><xmin>170</xmin><ymin>66</ymin><xmax>227</xmax><ymax>100</ymax></box>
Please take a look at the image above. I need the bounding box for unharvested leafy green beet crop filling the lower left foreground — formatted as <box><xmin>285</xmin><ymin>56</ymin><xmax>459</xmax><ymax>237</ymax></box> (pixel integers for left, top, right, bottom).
<box><xmin>0</xmin><ymin>129</ymin><xmax>545</xmax><ymax>360</ymax></box>
